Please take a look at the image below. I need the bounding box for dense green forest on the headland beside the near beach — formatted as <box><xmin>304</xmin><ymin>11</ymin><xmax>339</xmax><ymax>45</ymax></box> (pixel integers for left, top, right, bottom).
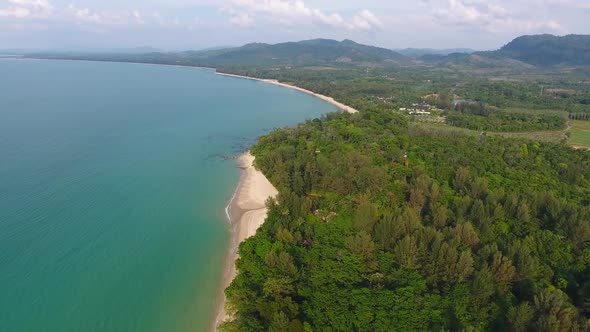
<box><xmin>223</xmin><ymin>109</ymin><xmax>590</xmax><ymax>331</ymax></box>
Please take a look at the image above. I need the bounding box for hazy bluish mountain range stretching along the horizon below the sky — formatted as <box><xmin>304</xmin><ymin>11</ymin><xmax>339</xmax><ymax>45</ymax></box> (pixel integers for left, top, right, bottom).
<box><xmin>25</xmin><ymin>35</ymin><xmax>590</xmax><ymax>67</ymax></box>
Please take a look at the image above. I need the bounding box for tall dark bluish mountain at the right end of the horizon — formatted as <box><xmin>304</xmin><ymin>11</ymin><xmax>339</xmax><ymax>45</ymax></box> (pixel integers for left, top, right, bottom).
<box><xmin>476</xmin><ymin>34</ymin><xmax>590</xmax><ymax>66</ymax></box>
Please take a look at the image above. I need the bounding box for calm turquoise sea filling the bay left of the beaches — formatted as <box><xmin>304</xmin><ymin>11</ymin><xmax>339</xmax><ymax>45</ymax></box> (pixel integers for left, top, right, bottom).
<box><xmin>0</xmin><ymin>60</ymin><xmax>335</xmax><ymax>332</ymax></box>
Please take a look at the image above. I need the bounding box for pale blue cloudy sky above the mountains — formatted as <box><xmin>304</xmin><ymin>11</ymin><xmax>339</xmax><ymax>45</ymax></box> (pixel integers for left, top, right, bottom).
<box><xmin>0</xmin><ymin>0</ymin><xmax>590</xmax><ymax>50</ymax></box>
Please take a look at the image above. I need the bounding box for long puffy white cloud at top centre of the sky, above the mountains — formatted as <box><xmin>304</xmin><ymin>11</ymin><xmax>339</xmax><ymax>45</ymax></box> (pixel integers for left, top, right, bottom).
<box><xmin>222</xmin><ymin>0</ymin><xmax>382</xmax><ymax>30</ymax></box>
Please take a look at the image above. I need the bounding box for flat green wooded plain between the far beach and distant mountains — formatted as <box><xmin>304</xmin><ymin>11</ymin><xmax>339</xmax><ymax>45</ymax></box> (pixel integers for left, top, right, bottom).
<box><xmin>218</xmin><ymin>65</ymin><xmax>590</xmax><ymax>114</ymax></box>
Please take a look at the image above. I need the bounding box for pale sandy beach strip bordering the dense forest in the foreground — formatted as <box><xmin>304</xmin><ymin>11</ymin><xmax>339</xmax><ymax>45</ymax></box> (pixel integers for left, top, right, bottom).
<box><xmin>212</xmin><ymin>151</ymin><xmax>278</xmax><ymax>331</ymax></box>
